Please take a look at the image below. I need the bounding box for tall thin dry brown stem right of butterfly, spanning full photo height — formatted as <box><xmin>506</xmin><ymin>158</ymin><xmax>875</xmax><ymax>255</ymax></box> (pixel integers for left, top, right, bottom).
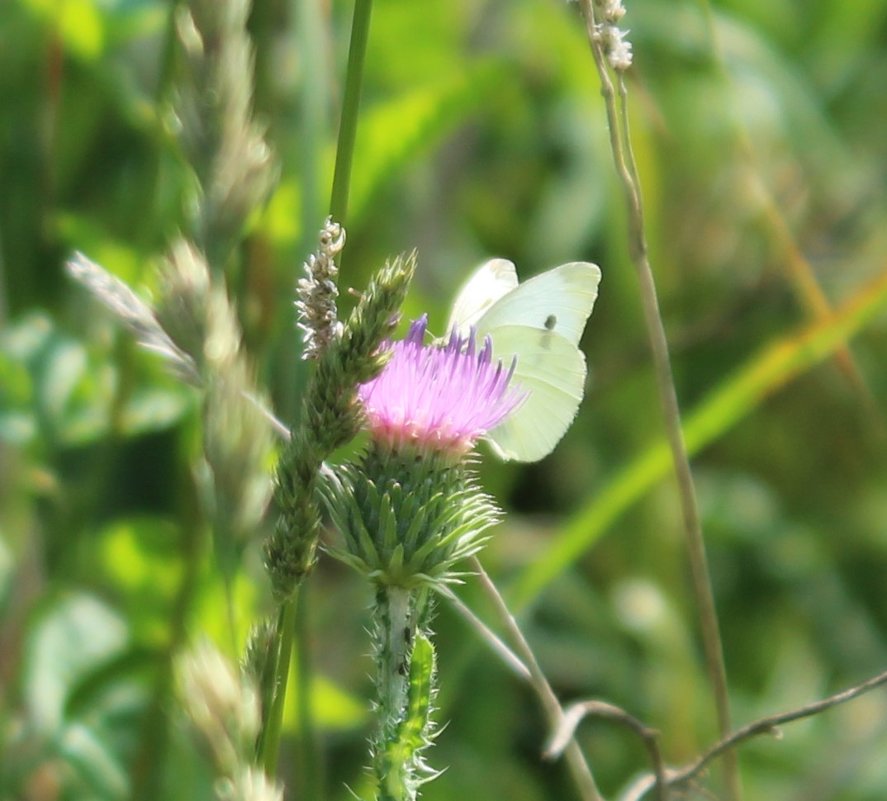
<box><xmin>581</xmin><ymin>0</ymin><xmax>741</xmax><ymax>801</ymax></box>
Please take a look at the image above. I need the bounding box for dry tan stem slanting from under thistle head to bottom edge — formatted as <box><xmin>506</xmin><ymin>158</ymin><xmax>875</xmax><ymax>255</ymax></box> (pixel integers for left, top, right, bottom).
<box><xmin>471</xmin><ymin>556</ymin><xmax>603</xmax><ymax>801</ymax></box>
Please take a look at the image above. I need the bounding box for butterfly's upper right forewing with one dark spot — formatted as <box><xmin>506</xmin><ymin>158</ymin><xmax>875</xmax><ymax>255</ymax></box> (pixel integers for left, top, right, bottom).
<box><xmin>476</xmin><ymin>261</ymin><xmax>601</xmax><ymax>346</ymax></box>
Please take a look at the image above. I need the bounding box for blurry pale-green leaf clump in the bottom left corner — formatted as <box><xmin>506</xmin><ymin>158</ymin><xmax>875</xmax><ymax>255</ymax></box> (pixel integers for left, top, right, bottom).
<box><xmin>0</xmin><ymin>593</ymin><xmax>145</xmax><ymax>799</ymax></box>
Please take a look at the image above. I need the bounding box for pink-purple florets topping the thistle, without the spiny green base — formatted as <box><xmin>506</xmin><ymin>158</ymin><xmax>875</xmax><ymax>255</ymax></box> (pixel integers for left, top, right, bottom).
<box><xmin>358</xmin><ymin>315</ymin><xmax>526</xmax><ymax>456</ymax></box>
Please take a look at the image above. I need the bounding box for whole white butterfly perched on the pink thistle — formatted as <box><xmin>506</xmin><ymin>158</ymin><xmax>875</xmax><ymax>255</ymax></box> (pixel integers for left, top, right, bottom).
<box><xmin>447</xmin><ymin>259</ymin><xmax>601</xmax><ymax>462</ymax></box>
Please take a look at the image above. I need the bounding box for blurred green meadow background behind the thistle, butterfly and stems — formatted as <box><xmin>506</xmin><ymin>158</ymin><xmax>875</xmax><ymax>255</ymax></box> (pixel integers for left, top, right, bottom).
<box><xmin>0</xmin><ymin>0</ymin><xmax>887</xmax><ymax>801</ymax></box>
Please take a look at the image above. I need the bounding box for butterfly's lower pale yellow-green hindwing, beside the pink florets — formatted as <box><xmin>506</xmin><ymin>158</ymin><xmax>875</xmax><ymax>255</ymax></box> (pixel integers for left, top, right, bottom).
<box><xmin>487</xmin><ymin>325</ymin><xmax>586</xmax><ymax>462</ymax></box>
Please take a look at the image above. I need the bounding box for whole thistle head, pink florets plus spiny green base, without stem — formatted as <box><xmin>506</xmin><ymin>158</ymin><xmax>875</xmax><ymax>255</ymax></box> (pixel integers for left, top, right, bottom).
<box><xmin>323</xmin><ymin>316</ymin><xmax>524</xmax><ymax>588</ymax></box>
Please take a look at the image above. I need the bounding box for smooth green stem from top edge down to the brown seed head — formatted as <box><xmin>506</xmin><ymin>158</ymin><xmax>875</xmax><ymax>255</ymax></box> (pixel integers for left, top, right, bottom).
<box><xmin>330</xmin><ymin>0</ymin><xmax>373</xmax><ymax>227</ymax></box>
